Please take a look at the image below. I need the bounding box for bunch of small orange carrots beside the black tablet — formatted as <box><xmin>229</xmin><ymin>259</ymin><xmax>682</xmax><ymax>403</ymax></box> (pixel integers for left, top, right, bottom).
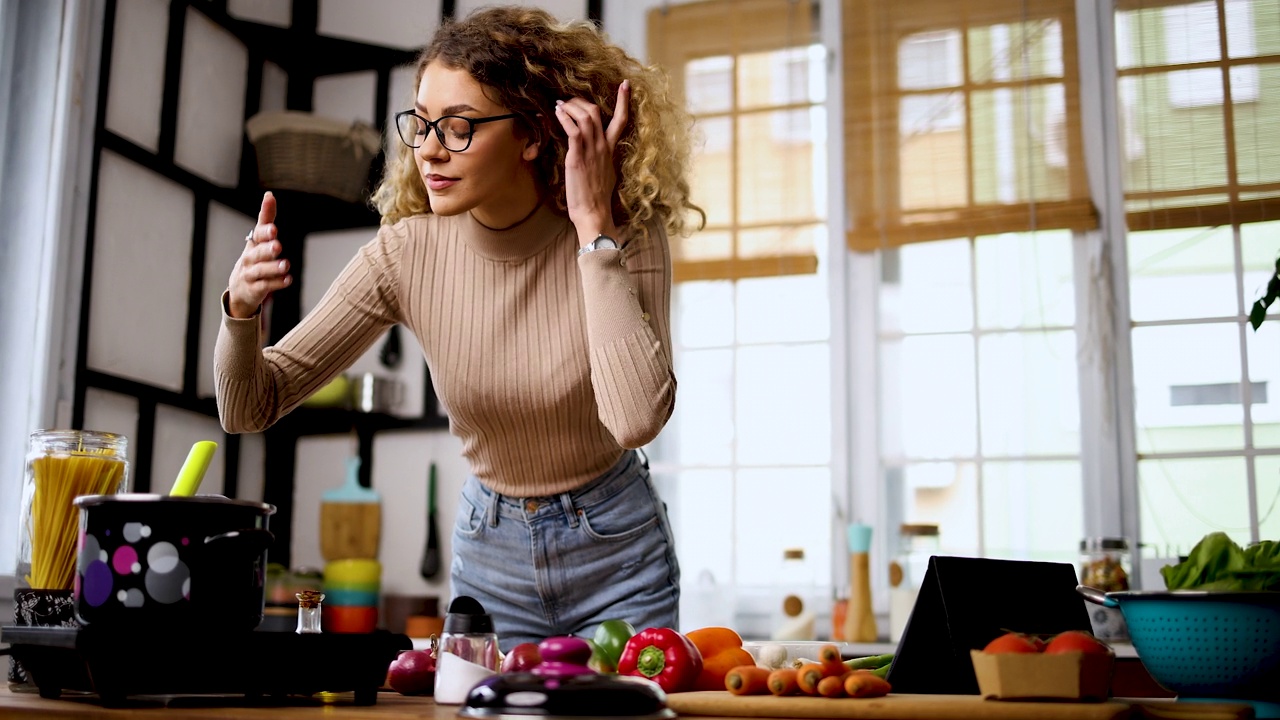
<box><xmin>724</xmin><ymin>644</ymin><xmax>892</xmax><ymax>697</ymax></box>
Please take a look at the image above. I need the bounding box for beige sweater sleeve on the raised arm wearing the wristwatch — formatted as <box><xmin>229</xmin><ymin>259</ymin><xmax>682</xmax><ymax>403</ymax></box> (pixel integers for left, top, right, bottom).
<box><xmin>577</xmin><ymin>223</ymin><xmax>676</xmax><ymax>447</ymax></box>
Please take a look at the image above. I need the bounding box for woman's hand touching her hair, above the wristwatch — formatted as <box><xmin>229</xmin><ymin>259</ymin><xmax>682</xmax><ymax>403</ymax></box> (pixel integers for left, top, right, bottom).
<box><xmin>556</xmin><ymin>81</ymin><xmax>631</xmax><ymax>245</ymax></box>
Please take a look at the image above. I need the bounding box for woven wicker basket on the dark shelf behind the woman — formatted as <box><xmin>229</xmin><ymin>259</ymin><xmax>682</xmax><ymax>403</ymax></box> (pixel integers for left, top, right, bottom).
<box><xmin>244</xmin><ymin>111</ymin><xmax>381</xmax><ymax>202</ymax></box>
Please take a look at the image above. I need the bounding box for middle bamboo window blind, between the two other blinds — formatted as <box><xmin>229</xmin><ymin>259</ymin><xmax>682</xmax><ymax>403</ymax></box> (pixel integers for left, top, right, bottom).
<box><xmin>842</xmin><ymin>0</ymin><xmax>1097</xmax><ymax>251</ymax></box>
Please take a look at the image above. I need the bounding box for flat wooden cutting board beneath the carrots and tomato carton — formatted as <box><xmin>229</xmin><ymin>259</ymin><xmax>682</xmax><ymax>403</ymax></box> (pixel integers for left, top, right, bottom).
<box><xmin>667</xmin><ymin>691</ymin><xmax>1253</xmax><ymax>720</ymax></box>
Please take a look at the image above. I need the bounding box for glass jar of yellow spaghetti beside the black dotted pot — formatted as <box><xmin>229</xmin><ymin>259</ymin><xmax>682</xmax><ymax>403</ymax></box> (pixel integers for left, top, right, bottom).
<box><xmin>17</xmin><ymin>430</ymin><xmax>129</xmax><ymax>591</ymax></box>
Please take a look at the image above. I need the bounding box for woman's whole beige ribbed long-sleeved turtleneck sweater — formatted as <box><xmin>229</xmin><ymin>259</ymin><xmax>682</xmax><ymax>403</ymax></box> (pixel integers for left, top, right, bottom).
<box><xmin>214</xmin><ymin>206</ymin><xmax>676</xmax><ymax>497</ymax></box>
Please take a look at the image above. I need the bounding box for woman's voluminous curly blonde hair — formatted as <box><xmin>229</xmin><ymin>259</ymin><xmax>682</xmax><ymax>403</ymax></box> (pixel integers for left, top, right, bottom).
<box><xmin>371</xmin><ymin>6</ymin><xmax>707</xmax><ymax>240</ymax></box>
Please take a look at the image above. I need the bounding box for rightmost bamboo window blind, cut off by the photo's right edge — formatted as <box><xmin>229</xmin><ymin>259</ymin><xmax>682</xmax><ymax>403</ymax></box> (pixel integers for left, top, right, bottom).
<box><xmin>1115</xmin><ymin>0</ymin><xmax>1280</xmax><ymax>231</ymax></box>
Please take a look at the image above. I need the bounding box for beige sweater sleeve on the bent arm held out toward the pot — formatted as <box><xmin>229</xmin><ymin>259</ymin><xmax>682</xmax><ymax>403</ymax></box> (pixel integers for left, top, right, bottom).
<box><xmin>214</xmin><ymin>225</ymin><xmax>403</xmax><ymax>433</ymax></box>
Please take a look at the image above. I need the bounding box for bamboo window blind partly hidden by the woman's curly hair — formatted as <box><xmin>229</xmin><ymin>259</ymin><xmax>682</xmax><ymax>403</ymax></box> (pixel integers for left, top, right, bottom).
<box><xmin>648</xmin><ymin>0</ymin><xmax>828</xmax><ymax>282</ymax></box>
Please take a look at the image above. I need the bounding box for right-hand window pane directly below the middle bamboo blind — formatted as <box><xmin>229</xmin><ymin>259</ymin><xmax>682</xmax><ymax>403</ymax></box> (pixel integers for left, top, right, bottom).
<box><xmin>974</xmin><ymin>231</ymin><xmax>1075</xmax><ymax>329</ymax></box>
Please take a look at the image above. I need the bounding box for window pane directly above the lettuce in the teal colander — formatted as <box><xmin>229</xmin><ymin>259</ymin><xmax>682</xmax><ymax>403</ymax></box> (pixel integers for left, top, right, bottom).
<box><xmin>1138</xmin><ymin>457</ymin><xmax>1249</xmax><ymax>555</ymax></box>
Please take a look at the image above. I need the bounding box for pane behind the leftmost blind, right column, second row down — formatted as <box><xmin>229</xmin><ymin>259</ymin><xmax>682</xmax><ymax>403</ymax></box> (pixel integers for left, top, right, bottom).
<box><xmin>737</xmin><ymin>108</ymin><xmax>826</xmax><ymax>224</ymax></box>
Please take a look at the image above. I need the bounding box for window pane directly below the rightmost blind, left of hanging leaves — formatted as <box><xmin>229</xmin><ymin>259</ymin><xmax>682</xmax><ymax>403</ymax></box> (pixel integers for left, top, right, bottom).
<box><xmin>1129</xmin><ymin>227</ymin><xmax>1238</xmax><ymax>322</ymax></box>
